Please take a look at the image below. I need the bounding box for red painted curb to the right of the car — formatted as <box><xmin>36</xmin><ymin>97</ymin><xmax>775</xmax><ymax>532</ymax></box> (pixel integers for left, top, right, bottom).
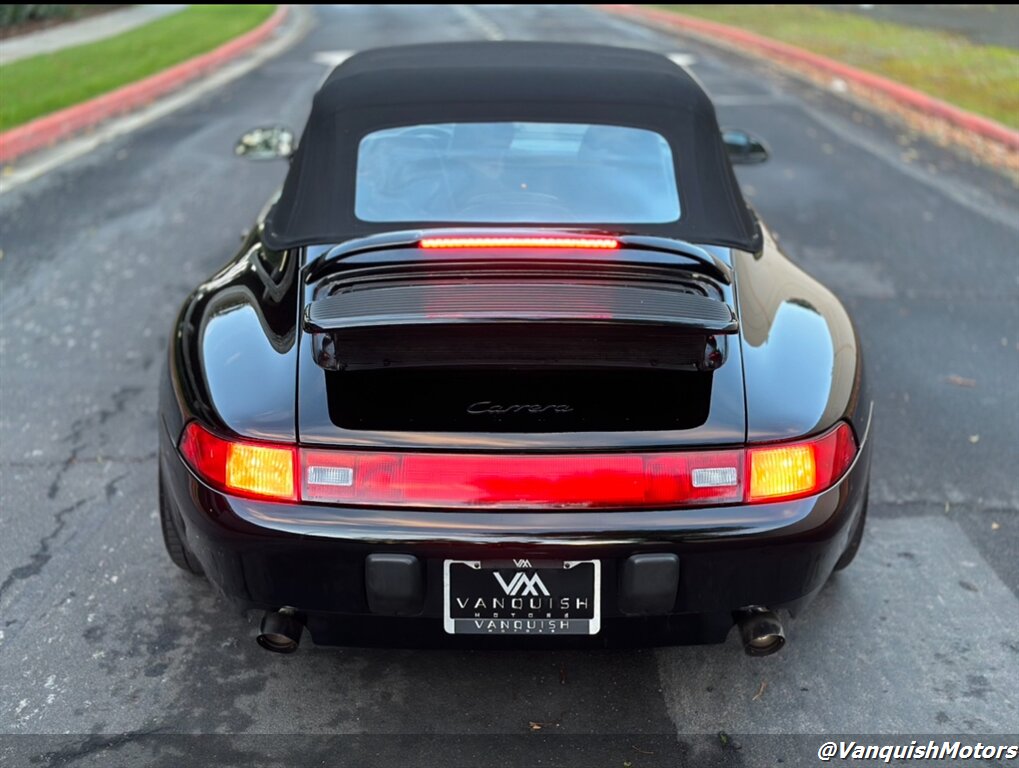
<box><xmin>599</xmin><ymin>5</ymin><xmax>1019</xmax><ymax>152</ymax></box>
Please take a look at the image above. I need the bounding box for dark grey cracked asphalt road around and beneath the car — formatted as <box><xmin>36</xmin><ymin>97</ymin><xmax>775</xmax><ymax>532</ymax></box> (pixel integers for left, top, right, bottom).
<box><xmin>0</xmin><ymin>6</ymin><xmax>1019</xmax><ymax>766</ymax></box>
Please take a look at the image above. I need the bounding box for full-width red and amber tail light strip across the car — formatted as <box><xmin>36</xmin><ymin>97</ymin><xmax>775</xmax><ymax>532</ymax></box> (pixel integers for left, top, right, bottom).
<box><xmin>180</xmin><ymin>423</ymin><xmax>857</xmax><ymax>509</ymax></box>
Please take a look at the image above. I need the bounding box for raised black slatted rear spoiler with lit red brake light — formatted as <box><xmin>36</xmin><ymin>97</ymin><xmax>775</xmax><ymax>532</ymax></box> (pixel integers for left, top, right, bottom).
<box><xmin>304</xmin><ymin>230</ymin><xmax>739</xmax><ymax>371</ymax></box>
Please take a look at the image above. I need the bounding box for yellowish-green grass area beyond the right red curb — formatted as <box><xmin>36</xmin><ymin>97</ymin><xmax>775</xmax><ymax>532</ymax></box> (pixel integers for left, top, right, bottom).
<box><xmin>662</xmin><ymin>5</ymin><xmax>1019</xmax><ymax>128</ymax></box>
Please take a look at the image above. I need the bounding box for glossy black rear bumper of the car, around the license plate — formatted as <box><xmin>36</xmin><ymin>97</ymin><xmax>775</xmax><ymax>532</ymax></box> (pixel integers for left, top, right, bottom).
<box><xmin>160</xmin><ymin>415</ymin><xmax>870</xmax><ymax>646</ymax></box>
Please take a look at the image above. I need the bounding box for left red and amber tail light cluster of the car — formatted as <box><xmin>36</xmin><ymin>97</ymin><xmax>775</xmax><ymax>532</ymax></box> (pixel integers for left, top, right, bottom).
<box><xmin>180</xmin><ymin>422</ymin><xmax>298</xmax><ymax>501</ymax></box>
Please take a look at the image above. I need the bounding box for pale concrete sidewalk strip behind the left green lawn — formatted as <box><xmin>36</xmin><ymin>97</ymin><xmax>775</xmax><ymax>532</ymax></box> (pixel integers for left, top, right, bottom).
<box><xmin>0</xmin><ymin>5</ymin><xmax>187</xmax><ymax>65</ymax></box>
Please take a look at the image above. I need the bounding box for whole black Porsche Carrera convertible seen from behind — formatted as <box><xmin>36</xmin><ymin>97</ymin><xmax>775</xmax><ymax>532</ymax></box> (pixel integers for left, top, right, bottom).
<box><xmin>159</xmin><ymin>43</ymin><xmax>871</xmax><ymax>655</ymax></box>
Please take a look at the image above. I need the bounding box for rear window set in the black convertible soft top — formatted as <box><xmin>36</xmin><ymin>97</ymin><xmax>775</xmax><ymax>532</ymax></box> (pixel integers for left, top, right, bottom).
<box><xmin>355</xmin><ymin>122</ymin><xmax>680</xmax><ymax>224</ymax></box>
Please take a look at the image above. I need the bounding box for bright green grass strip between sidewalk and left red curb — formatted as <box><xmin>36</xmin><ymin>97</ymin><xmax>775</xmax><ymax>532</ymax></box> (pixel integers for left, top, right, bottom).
<box><xmin>0</xmin><ymin>5</ymin><xmax>276</xmax><ymax>130</ymax></box>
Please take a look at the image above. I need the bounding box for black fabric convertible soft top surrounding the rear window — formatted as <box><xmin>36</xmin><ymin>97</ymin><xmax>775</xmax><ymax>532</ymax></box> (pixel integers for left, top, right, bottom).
<box><xmin>263</xmin><ymin>42</ymin><xmax>760</xmax><ymax>252</ymax></box>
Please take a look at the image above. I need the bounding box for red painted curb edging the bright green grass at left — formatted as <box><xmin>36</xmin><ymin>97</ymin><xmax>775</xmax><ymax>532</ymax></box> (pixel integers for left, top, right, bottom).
<box><xmin>0</xmin><ymin>5</ymin><xmax>289</xmax><ymax>163</ymax></box>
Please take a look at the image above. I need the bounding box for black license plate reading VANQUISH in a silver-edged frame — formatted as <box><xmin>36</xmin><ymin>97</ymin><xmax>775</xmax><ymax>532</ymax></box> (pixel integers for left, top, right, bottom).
<box><xmin>442</xmin><ymin>560</ymin><xmax>601</xmax><ymax>636</ymax></box>
